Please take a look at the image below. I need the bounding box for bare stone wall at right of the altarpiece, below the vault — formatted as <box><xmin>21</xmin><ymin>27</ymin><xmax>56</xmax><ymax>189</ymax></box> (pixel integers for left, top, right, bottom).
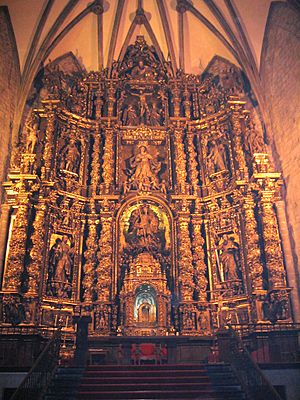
<box><xmin>261</xmin><ymin>2</ymin><xmax>300</xmax><ymax>290</ymax></box>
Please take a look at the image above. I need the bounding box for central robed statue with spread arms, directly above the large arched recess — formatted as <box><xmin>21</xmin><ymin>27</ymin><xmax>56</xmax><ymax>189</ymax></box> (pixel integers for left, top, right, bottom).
<box><xmin>126</xmin><ymin>145</ymin><xmax>161</xmax><ymax>190</ymax></box>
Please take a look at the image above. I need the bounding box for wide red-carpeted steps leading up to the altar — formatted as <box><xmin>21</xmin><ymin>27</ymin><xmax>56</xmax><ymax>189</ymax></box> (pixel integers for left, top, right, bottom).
<box><xmin>74</xmin><ymin>364</ymin><xmax>245</xmax><ymax>400</ymax></box>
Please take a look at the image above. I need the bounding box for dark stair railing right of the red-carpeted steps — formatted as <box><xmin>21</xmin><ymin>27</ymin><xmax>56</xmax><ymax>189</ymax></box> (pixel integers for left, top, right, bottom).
<box><xmin>217</xmin><ymin>327</ymin><xmax>282</xmax><ymax>400</ymax></box>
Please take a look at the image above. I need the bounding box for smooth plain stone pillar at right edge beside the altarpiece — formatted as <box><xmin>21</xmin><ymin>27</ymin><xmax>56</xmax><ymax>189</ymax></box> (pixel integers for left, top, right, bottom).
<box><xmin>275</xmin><ymin>200</ymin><xmax>300</xmax><ymax>323</ymax></box>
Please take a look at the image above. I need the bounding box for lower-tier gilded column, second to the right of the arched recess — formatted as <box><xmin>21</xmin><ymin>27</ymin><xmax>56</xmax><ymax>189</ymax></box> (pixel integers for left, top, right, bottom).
<box><xmin>192</xmin><ymin>214</ymin><xmax>207</xmax><ymax>301</ymax></box>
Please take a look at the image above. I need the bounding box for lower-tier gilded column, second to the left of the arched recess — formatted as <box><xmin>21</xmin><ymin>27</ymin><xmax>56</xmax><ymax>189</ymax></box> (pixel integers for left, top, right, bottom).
<box><xmin>82</xmin><ymin>212</ymin><xmax>98</xmax><ymax>304</ymax></box>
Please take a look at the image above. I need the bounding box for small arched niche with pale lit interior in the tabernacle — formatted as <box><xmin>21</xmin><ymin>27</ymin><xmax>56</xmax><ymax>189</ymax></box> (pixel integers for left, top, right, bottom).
<box><xmin>134</xmin><ymin>284</ymin><xmax>157</xmax><ymax>326</ymax></box>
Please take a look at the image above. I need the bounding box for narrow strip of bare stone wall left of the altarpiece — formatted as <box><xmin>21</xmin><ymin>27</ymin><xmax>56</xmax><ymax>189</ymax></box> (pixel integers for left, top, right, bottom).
<box><xmin>0</xmin><ymin>7</ymin><xmax>20</xmax><ymax>204</ymax></box>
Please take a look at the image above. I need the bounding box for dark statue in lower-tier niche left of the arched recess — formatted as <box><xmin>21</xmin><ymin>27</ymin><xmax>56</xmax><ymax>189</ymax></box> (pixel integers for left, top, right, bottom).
<box><xmin>48</xmin><ymin>235</ymin><xmax>74</xmax><ymax>298</ymax></box>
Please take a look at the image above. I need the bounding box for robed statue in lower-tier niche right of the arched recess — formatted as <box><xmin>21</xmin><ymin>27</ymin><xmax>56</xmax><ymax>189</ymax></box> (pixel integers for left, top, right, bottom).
<box><xmin>217</xmin><ymin>234</ymin><xmax>239</xmax><ymax>281</ymax></box>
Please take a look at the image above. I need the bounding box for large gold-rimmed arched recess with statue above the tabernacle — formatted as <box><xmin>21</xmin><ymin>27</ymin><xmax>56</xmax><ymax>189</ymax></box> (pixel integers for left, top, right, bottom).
<box><xmin>113</xmin><ymin>196</ymin><xmax>178</xmax><ymax>294</ymax></box>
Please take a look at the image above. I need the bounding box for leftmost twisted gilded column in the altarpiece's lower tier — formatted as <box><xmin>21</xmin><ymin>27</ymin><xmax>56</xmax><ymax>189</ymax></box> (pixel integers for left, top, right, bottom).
<box><xmin>2</xmin><ymin>193</ymin><xmax>29</xmax><ymax>293</ymax></box>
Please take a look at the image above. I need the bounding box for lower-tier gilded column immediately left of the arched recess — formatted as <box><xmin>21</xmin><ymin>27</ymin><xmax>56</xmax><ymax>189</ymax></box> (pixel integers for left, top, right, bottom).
<box><xmin>96</xmin><ymin>210</ymin><xmax>113</xmax><ymax>302</ymax></box>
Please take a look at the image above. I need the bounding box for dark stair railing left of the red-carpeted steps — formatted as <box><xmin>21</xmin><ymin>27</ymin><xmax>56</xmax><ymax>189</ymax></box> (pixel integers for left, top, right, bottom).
<box><xmin>10</xmin><ymin>330</ymin><xmax>61</xmax><ymax>400</ymax></box>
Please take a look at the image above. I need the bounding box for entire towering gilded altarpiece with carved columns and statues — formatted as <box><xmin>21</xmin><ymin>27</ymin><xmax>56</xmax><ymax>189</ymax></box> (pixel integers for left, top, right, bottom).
<box><xmin>0</xmin><ymin>34</ymin><xmax>291</xmax><ymax>338</ymax></box>
